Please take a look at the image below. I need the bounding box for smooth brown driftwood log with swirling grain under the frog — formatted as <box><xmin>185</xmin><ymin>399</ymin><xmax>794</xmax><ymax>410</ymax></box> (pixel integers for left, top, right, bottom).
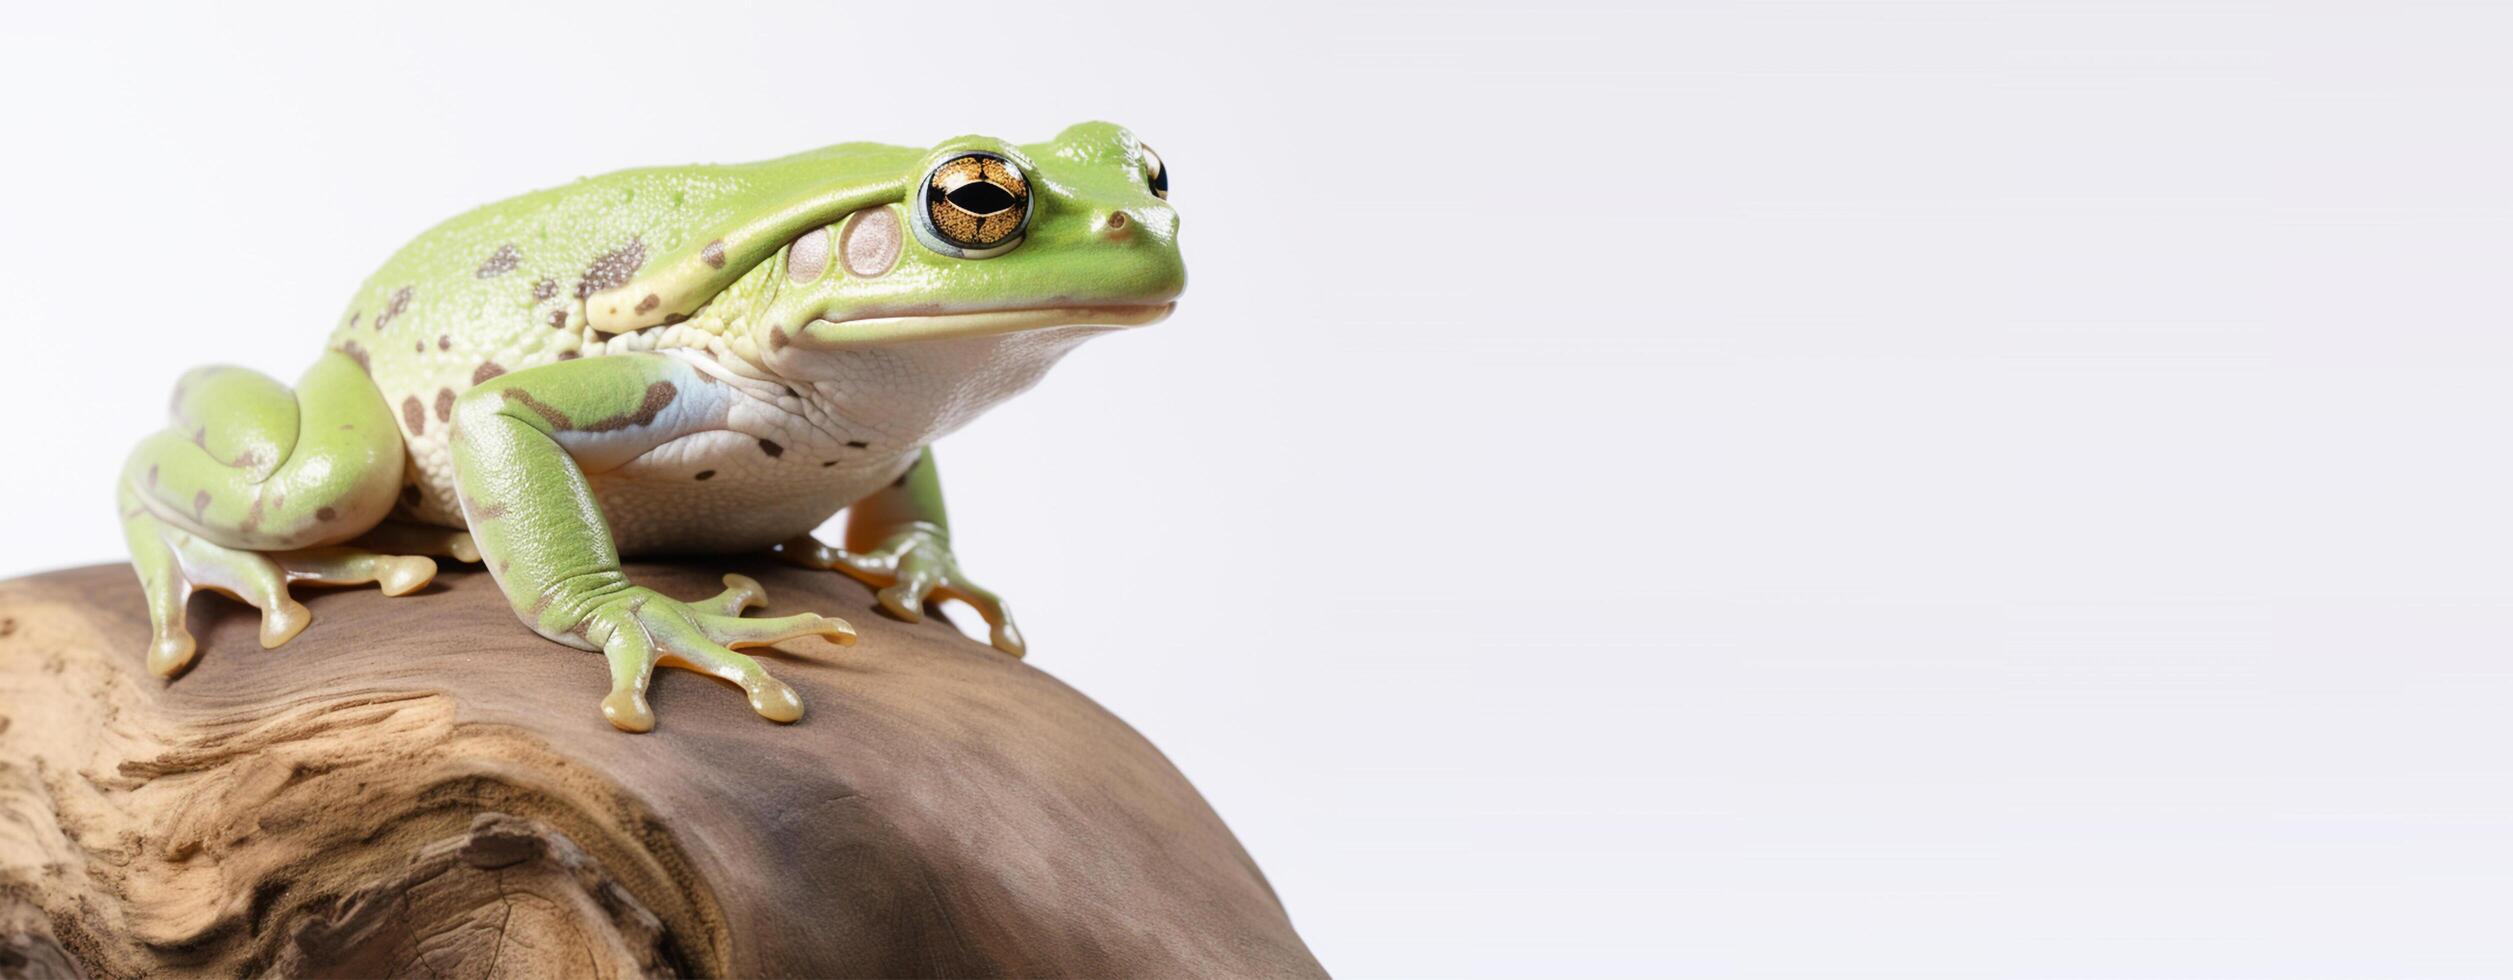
<box><xmin>0</xmin><ymin>563</ymin><xmax>1322</xmax><ymax>977</ymax></box>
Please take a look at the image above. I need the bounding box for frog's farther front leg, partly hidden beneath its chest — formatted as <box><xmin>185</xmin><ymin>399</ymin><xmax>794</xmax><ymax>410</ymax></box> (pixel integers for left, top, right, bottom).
<box><xmin>777</xmin><ymin>447</ymin><xmax>1028</xmax><ymax>656</ymax></box>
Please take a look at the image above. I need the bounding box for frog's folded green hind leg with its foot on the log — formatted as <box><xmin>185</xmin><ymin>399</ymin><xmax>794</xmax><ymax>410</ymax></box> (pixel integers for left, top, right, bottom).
<box><xmin>118</xmin><ymin>354</ymin><xmax>435</xmax><ymax>676</ymax></box>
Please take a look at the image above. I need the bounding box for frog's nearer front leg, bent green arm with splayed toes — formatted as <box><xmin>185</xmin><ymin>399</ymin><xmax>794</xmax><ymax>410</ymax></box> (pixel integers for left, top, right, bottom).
<box><xmin>452</xmin><ymin>354</ymin><xmax>854</xmax><ymax>731</ymax></box>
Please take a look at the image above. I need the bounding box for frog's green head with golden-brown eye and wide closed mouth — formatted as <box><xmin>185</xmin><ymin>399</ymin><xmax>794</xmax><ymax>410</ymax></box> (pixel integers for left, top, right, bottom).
<box><xmin>751</xmin><ymin>123</ymin><xmax>1186</xmax><ymax>359</ymax></box>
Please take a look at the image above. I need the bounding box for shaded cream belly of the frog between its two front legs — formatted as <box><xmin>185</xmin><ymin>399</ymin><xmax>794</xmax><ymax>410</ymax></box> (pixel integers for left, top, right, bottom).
<box><xmin>588</xmin><ymin>430</ymin><xmax>915</xmax><ymax>555</ymax></box>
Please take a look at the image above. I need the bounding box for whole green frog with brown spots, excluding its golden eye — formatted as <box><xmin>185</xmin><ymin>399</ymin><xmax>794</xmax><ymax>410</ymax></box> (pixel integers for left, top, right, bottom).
<box><xmin>118</xmin><ymin>123</ymin><xmax>1186</xmax><ymax>731</ymax></box>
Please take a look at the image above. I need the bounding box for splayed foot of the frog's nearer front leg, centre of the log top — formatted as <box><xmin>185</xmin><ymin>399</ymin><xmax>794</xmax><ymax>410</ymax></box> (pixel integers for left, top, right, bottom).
<box><xmin>581</xmin><ymin>575</ymin><xmax>854</xmax><ymax>731</ymax></box>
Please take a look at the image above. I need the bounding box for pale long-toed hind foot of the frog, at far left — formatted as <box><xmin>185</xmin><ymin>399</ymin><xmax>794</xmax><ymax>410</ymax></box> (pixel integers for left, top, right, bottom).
<box><xmin>123</xmin><ymin>490</ymin><xmax>437</xmax><ymax>676</ymax></box>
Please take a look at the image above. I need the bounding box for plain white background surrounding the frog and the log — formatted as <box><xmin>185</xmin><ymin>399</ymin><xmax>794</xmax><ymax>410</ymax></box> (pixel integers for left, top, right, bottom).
<box><xmin>0</xmin><ymin>0</ymin><xmax>2513</xmax><ymax>977</ymax></box>
